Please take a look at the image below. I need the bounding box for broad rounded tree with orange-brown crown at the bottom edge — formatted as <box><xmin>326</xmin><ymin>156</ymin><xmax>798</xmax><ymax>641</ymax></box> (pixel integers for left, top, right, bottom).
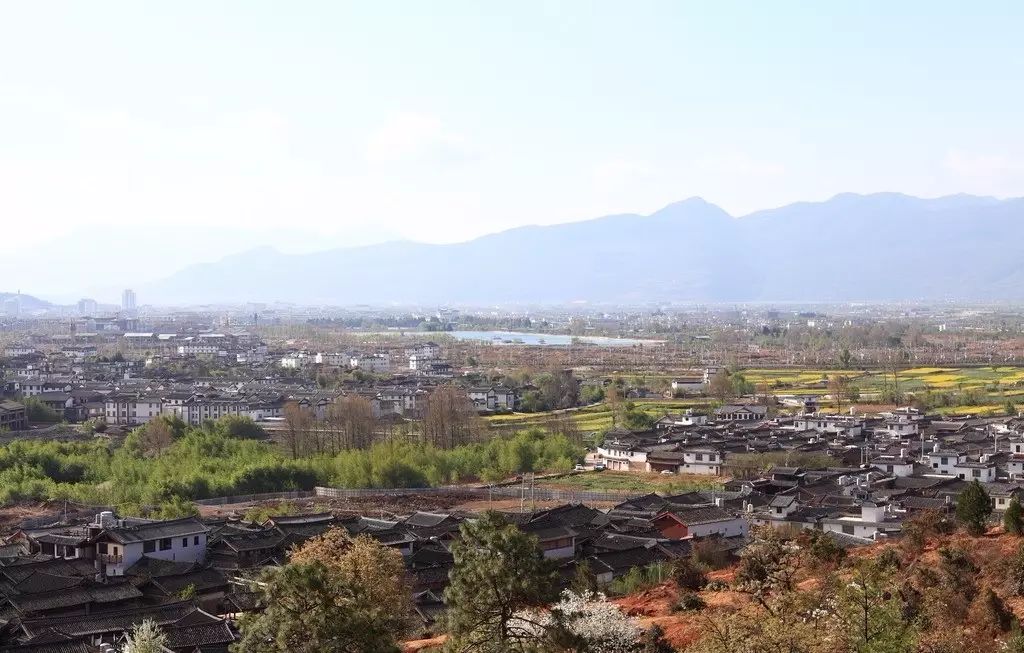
<box><xmin>231</xmin><ymin>562</ymin><xmax>399</xmax><ymax>653</ymax></box>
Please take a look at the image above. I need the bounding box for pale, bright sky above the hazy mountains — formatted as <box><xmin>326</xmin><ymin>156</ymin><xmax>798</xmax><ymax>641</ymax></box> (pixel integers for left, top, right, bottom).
<box><xmin>0</xmin><ymin>0</ymin><xmax>1024</xmax><ymax>301</ymax></box>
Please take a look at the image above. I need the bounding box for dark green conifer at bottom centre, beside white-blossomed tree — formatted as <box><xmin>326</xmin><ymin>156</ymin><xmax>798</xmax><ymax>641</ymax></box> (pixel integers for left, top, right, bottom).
<box><xmin>444</xmin><ymin>512</ymin><xmax>555</xmax><ymax>653</ymax></box>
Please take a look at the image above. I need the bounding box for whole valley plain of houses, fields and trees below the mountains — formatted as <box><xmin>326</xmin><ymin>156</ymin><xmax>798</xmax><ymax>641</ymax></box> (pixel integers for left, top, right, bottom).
<box><xmin>0</xmin><ymin>290</ymin><xmax>1024</xmax><ymax>653</ymax></box>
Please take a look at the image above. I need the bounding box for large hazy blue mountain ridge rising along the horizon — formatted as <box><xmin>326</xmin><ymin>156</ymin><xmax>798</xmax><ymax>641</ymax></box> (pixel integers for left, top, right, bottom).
<box><xmin>141</xmin><ymin>193</ymin><xmax>1024</xmax><ymax>305</ymax></box>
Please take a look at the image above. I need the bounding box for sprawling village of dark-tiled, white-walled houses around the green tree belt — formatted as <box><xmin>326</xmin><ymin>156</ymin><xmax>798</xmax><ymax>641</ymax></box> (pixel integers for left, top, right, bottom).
<box><xmin>0</xmin><ymin>300</ymin><xmax>1024</xmax><ymax>653</ymax></box>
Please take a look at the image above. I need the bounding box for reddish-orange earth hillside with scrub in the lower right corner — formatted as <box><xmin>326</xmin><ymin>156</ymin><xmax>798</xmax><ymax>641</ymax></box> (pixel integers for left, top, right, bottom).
<box><xmin>613</xmin><ymin>529</ymin><xmax>1024</xmax><ymax>653</ymax></box>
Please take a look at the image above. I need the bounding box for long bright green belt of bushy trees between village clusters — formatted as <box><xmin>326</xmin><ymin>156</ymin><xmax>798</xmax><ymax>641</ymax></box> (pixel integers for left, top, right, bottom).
<box><xmin>0</xmin><ymin>418</ymin><xmax>583</xmax><ymax>516</ymax></box>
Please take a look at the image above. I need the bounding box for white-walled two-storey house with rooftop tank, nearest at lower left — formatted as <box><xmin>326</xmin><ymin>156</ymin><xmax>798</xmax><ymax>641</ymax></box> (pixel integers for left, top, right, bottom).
<box><xmin>91</xmin><ymin>512</ymin><xmax>209</xmax><ymax>576</ymax></box>
